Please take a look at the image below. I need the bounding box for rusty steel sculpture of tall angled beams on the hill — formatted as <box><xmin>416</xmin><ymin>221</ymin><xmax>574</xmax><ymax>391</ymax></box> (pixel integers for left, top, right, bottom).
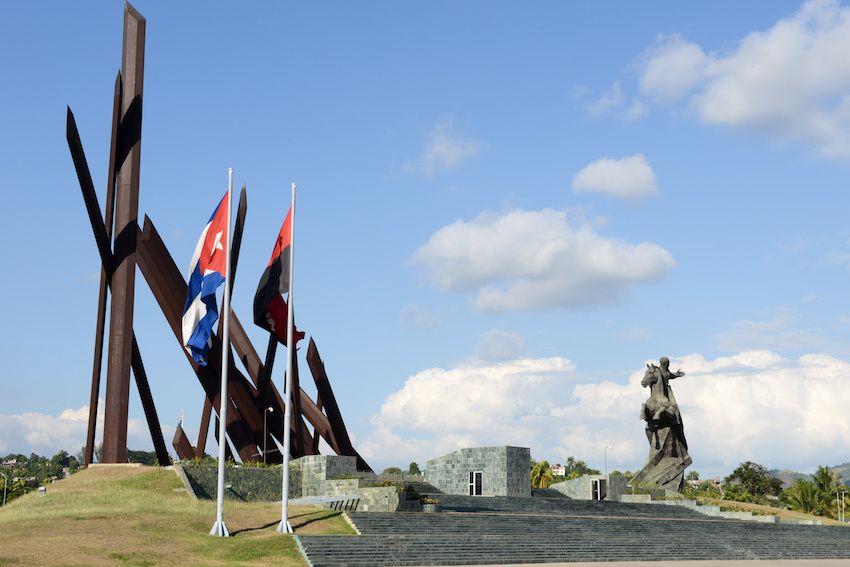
<box><xmin>66</xmin><ymin>3</ymin><xmax>371</xmax><ymax>471</ymax></box>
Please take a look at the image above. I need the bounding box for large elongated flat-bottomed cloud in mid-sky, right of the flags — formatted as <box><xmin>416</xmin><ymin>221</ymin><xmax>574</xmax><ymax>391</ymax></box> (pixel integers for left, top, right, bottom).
<box><xmin>413</xmin><ymin>209</ymin><xmax>674</xmax><ymax>312</ymax></box>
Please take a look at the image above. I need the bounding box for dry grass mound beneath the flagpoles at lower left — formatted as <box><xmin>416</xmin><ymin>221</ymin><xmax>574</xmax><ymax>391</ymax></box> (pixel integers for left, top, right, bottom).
<box><xmin>0</xmin><ymin>466</ymin><xmax>354</xmax><ymax>567</ymax></box>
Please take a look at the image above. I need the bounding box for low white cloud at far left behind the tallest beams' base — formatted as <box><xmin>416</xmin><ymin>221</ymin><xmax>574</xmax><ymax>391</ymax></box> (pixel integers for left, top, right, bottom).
<box><xmin>0</xmin><ymin>399</ymin><xmax>147</xmax><ymax>456</ymax></box>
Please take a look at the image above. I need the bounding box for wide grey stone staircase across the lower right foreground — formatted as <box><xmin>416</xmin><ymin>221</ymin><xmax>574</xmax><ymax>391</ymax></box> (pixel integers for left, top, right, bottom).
<box><xmin>298</xmin><ymin>495</ymin><xmax>850</xmax><ymax>567</ymax></box>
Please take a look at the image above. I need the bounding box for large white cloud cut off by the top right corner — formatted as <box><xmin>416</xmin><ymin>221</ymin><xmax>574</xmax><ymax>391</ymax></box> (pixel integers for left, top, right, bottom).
<box><xmin>640</xmin><ymin>0</ymin><xmax>850</xmax><ymax>159</ymax></box>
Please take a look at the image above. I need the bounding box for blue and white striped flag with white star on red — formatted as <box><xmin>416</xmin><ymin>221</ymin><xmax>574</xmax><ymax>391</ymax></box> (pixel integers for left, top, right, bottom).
<box><xmin>183</xmin><ymin>193</ymin><xmax>230</xmax><ymax>366</ymax></box>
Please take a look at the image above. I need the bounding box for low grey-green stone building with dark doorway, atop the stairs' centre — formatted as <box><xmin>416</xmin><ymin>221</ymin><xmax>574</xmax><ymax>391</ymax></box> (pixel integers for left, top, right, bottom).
<box><xmin>425</xmin><ymin>447</ymin><xmax>531</xmax><ymax>496</ymax></box>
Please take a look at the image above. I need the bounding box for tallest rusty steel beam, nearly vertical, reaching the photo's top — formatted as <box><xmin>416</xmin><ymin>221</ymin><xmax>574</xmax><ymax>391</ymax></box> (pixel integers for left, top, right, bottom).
<box><xmin>102</xmin><ymin>3</ymin><xmax>146</xmax><ymax>463</ymax></box>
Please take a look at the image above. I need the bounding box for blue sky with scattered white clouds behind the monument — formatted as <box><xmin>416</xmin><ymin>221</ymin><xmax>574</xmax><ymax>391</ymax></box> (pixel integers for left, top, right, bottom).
<box><xmin>0</xmin><ymin>0</ymin><xmax>850</xmax><ymax>480</ymax></box>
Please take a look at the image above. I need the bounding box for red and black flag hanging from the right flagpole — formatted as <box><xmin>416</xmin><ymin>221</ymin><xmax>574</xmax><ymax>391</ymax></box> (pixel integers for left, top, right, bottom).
<box><xmin>254</xmin><ymin>209</ymin><xmax>304</xmax><ymax>344</ymax></box>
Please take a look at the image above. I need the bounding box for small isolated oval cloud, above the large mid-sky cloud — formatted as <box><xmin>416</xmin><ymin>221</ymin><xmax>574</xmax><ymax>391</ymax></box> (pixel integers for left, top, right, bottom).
<box><xmin>572</xmin><ymin>154</ymin><xmax>658</xmax><ymax>198</ymax></box>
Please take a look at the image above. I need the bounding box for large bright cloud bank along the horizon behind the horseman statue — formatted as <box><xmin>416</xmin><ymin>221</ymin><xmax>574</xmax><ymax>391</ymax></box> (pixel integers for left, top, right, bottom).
<box><xmin>360</xmin><ymin>351</ymin><xmax>850</xmax><ymax>475</ymax></box>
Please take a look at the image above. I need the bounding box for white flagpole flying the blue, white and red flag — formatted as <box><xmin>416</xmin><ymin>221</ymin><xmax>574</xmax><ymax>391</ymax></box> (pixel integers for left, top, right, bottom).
<box><xmin>210</xmin><ymin>167</ymin><xmax>233</xmax><ymax>537</ymax></box>
